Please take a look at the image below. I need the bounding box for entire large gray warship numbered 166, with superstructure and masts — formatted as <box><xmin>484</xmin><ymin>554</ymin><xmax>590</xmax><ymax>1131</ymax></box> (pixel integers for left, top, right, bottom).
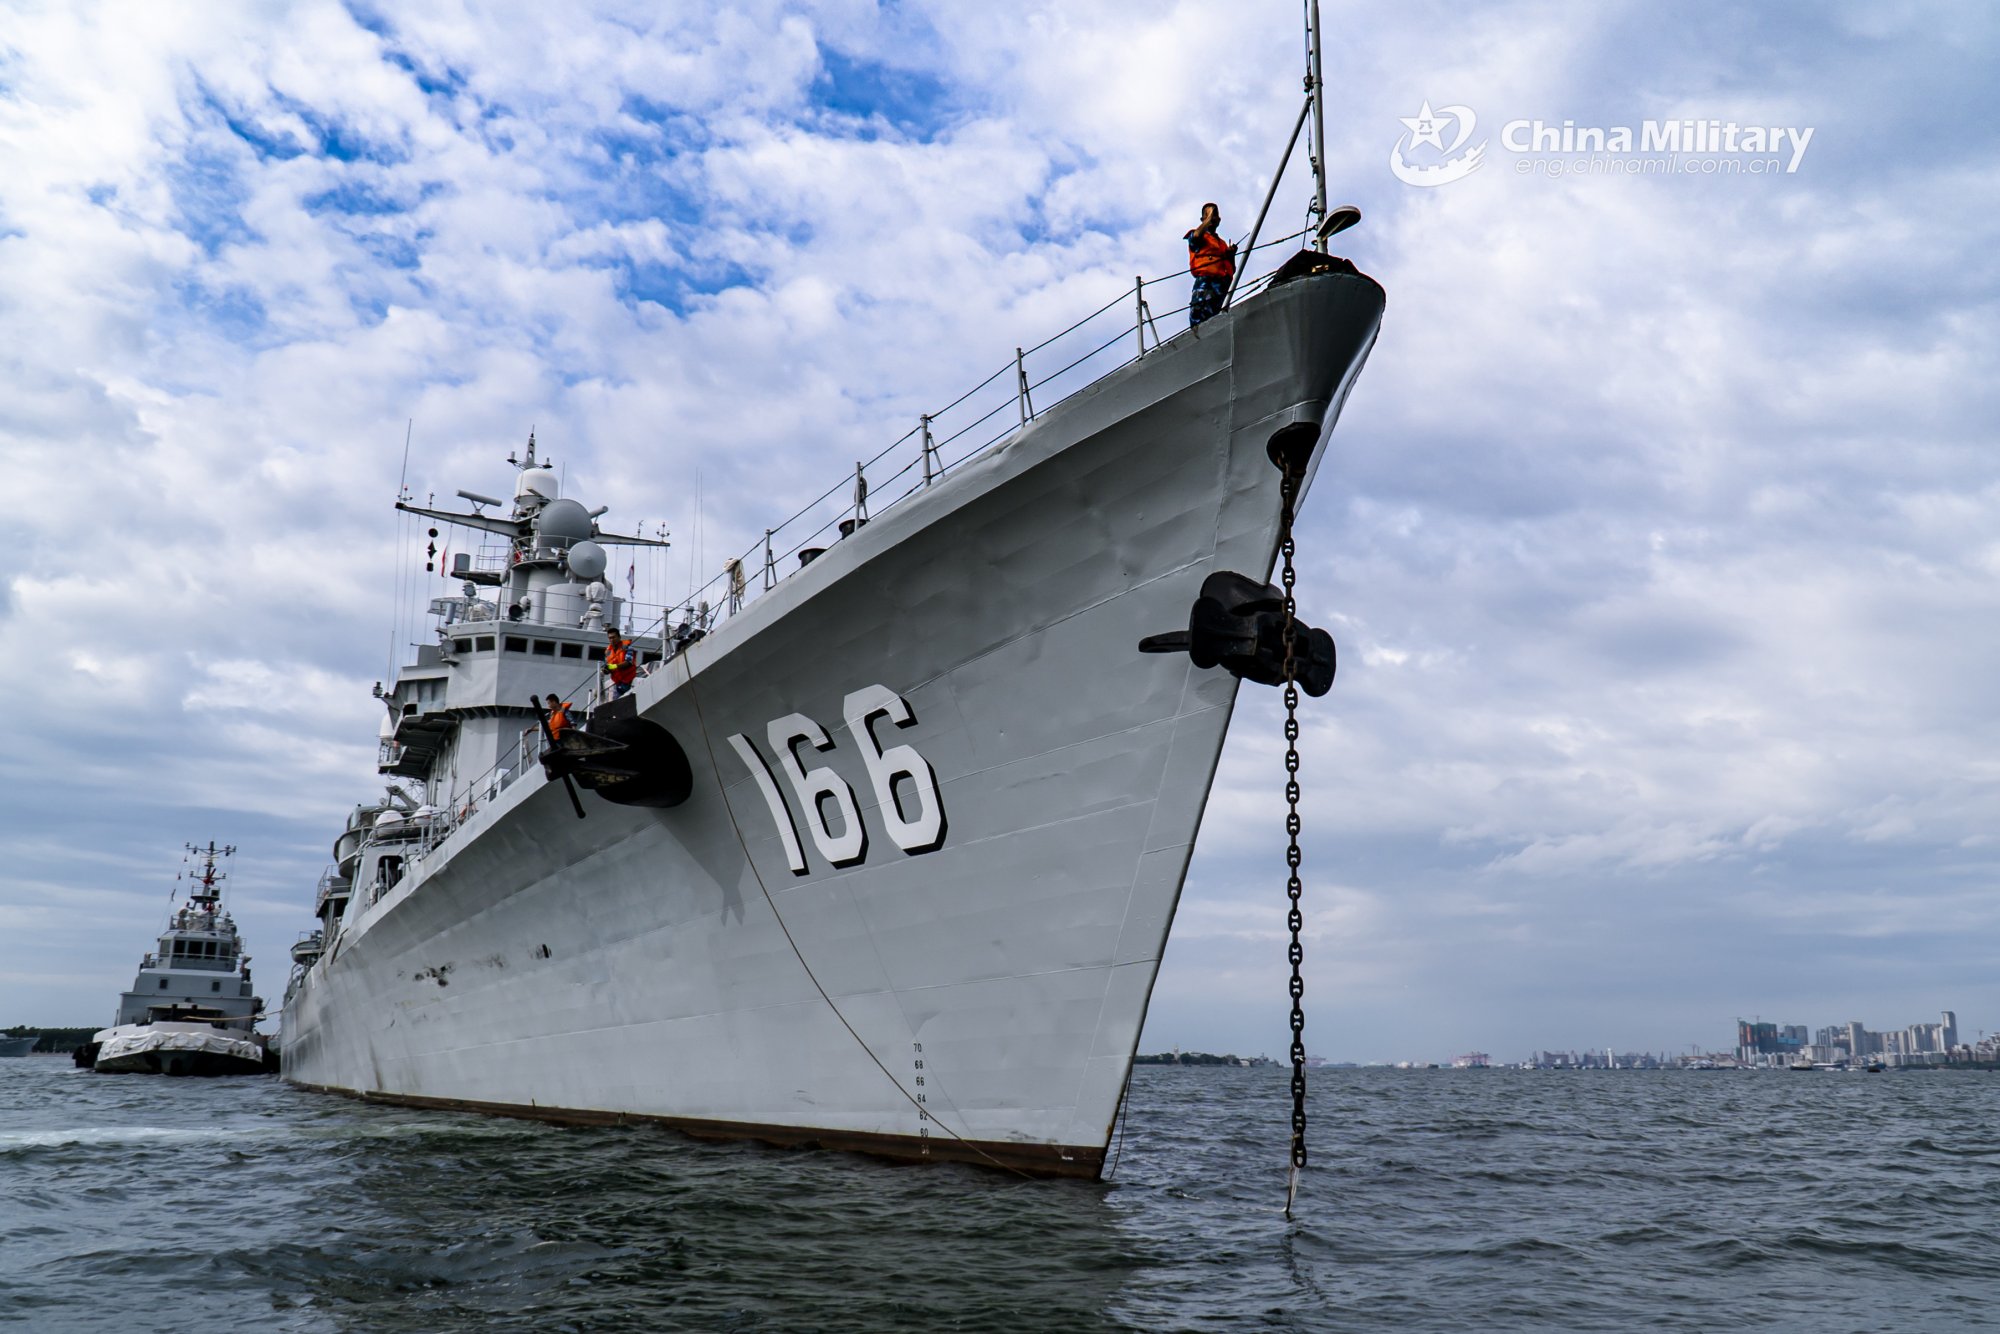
<box><xmin>280</xmin><ymin>15</ymin><xmax>1384</xmax><ymax>1178</ymax></box>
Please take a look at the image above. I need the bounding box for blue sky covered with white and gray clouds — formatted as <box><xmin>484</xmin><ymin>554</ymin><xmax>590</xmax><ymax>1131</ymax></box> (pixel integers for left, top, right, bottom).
<box><xmin>0</xmin><ymin>0</ymin><xmax>2000</xmax><ymax>1060</ymax></box>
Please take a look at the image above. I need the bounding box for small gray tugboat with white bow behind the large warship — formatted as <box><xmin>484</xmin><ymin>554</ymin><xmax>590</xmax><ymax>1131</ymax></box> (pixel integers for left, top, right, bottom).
<box><xmin>76</xmin><ymin>842</ymin><xmax>276</xmax><ymax>1074</ymax></box>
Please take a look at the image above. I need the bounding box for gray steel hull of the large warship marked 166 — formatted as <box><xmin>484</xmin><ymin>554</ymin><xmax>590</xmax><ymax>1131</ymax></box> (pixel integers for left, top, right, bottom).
<box><xmin>282</xmin><ymin>274</ymin><xmax>1382</xmax><ymax>1176</ymax></box>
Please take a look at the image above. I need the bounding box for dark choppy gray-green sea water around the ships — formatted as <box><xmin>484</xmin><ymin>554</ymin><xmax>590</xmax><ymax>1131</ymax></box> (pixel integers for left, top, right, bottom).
<box><xmin>0</xmin><ymin>1058</ymin><xmax>2000</xmax><ymax>1334</ymax></box>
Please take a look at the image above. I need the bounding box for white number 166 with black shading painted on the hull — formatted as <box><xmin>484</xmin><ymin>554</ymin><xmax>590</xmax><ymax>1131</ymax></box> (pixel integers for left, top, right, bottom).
<box><xmin>730</xmin><ymin>686</ymin><xmax>946</xmax><ymax>876</ymax></box>
